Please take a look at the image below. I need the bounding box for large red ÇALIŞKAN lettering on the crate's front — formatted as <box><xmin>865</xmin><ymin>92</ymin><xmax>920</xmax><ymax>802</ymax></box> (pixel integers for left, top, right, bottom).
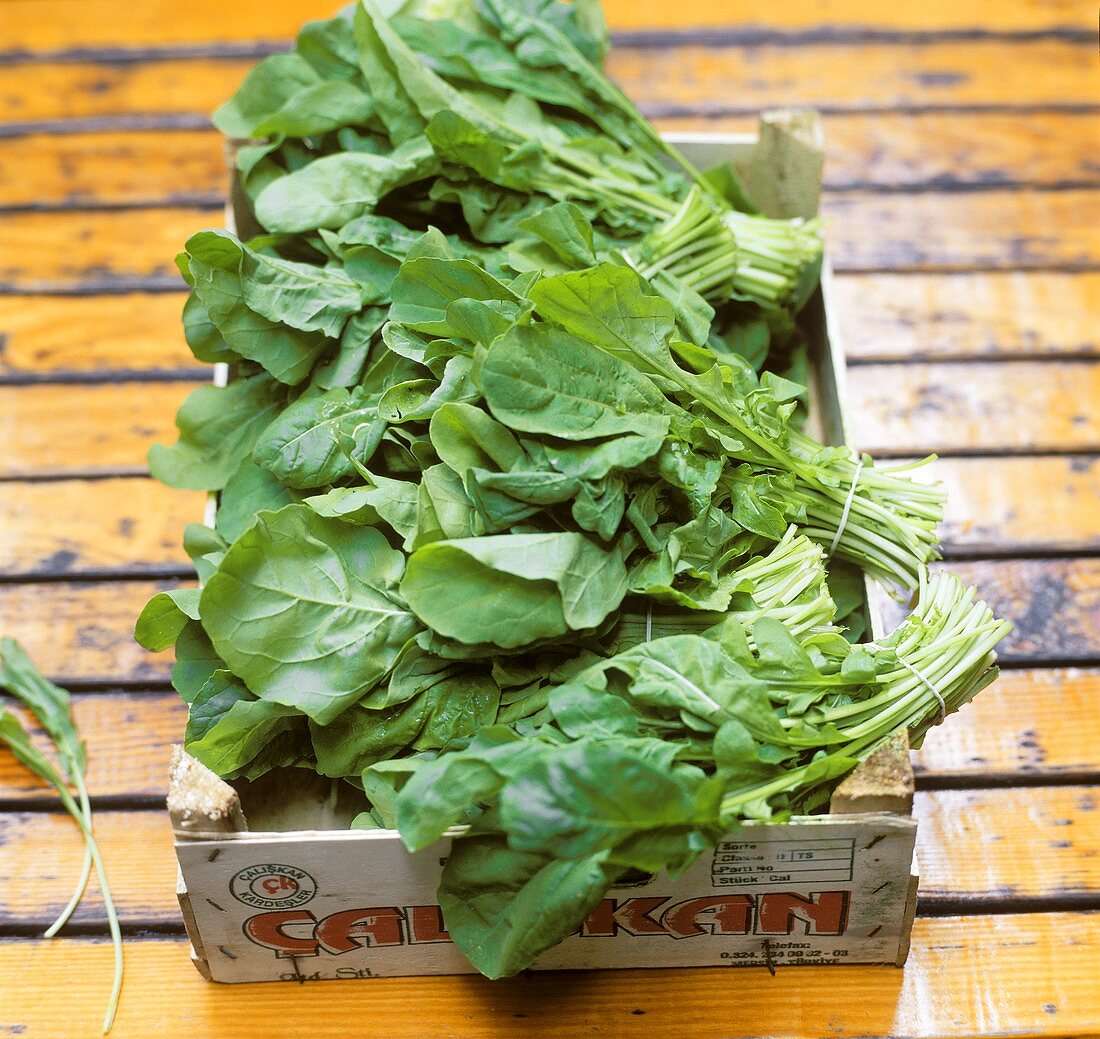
<box><xmin>244</xmin><ymin>891</ymin><xmax>850</xmax><ymax>957</ymax></box>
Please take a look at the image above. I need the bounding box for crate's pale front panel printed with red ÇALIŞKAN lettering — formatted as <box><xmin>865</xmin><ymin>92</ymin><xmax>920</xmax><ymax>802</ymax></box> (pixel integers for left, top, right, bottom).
<box><xmin>176</xmin><ymin>815</ymin><xmax>916</xmax><ymax>982</ymax></box>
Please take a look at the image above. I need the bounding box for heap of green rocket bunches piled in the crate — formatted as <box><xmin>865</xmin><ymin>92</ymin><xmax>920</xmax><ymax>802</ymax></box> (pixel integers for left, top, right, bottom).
<box><xmin>136</xmin><ymin>0</ymin><xmax>1004</xmax><ymax>976</ymax></box>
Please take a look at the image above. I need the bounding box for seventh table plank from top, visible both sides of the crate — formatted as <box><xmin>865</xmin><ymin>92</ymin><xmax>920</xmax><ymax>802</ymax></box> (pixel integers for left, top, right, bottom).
<box><xmin>0</xmin><ymin>455</ymin><xmax>1100</xmax><ymax>578</ymax></box>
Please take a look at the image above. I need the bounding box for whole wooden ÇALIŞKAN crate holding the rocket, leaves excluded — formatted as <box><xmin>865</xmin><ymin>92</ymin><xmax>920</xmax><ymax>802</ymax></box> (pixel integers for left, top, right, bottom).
<box><xmin>168</xmin><ymin>121</ymin><xmax>917</xmax><ymax>982</ymax></box>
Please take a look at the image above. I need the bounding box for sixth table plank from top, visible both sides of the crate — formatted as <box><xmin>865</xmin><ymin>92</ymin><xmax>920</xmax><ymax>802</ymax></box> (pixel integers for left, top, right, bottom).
<box><xmin>0</xmin><ymin>362</ymin><xmax>1100</xmax><ymax>479</ymax></box>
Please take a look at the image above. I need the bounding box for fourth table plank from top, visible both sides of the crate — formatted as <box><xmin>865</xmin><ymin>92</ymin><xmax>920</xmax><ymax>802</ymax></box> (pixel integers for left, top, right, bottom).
<box><xmin>0</xmin><ymin>189</ymin><xmax>1100</xmax><ymax>292</ymax></box>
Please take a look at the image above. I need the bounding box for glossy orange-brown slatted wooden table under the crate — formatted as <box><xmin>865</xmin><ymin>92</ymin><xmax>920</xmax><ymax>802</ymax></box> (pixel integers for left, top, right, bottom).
<box><xmin>0</xmin><ymin>0</ymin><xmax>1100</xmax><ymax>1039</ymax></box>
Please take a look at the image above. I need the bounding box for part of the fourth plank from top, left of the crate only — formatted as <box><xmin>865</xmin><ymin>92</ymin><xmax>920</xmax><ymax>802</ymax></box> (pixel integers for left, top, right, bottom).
<box><xmin>0</xmin><ymin>208</ymin><xmax>207</xmax><ymax>292</ymax></box>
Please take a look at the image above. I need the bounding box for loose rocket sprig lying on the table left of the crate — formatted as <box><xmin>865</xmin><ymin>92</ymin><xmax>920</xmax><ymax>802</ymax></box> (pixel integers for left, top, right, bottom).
<box><xmin>0</xmin><ymin>637</ymin><xmax>122</xmax><ymax>1034</ymax></box>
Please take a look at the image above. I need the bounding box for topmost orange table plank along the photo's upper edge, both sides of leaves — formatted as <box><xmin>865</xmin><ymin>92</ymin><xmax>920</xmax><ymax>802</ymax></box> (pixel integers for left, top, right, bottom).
<box><xmin>0</xmin><ymin>0</ymin><xmax>1092</xmax><ymax>52</ymax></box>
